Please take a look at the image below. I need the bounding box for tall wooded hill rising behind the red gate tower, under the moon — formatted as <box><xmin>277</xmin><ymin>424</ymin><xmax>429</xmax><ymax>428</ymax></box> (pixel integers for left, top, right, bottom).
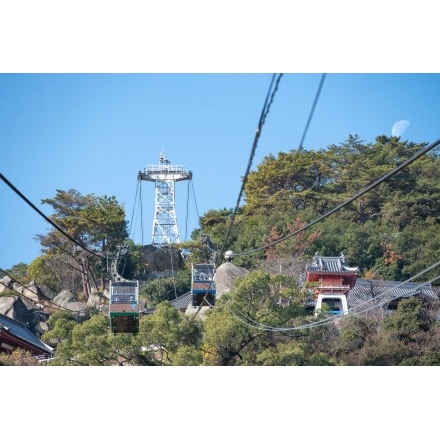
<box><xmin>201</xmin><ymin>136</ymin><xmax>440</xmax><ymax>280</ymax></box>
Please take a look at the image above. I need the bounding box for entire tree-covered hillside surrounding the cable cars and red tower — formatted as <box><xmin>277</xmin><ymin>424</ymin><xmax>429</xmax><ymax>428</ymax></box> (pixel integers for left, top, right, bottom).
<box><xmin>2</xmin><ymin>136</ymin><xmax>440</xmax><ymax>365</ymax></box>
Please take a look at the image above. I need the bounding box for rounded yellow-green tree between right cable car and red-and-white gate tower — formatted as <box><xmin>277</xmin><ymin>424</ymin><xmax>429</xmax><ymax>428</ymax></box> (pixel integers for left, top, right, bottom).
<box><xmin>203</xmin><ymin>270</ymin><xmax>306</xmax><ymax>365</ymax></box>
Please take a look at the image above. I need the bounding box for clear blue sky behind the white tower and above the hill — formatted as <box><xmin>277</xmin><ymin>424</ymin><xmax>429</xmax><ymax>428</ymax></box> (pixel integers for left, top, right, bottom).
<box><xmin>0</xmin><ymin>73</ymin><xmax>440</xmax><ymax>269</ymax></box>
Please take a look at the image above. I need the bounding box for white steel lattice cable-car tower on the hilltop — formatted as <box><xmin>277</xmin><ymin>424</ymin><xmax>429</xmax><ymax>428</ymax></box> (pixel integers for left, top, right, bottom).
<box><xmin>138</xmin><ymin>152</ymin><xmax>192</xmax><ymax>246</ymax></box>
